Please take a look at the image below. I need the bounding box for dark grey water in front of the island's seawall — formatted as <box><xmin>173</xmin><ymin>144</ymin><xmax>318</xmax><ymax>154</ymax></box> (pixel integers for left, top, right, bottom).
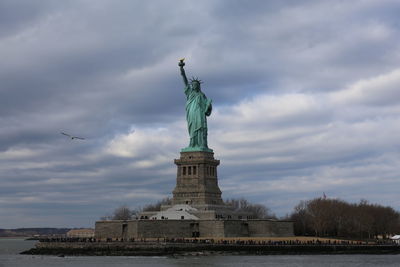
<box><xmin>0</xmin><ymin>239</ymin><xmax>400</xmax><ymax>267</ymax></box>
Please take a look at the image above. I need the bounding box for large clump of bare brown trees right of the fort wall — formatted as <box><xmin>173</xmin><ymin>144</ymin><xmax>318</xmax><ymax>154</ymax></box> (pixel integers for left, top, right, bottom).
<box><xmin>289</xmin><ymin>197</ymin><xmax>400</xmax><ymax>239</ymax></box>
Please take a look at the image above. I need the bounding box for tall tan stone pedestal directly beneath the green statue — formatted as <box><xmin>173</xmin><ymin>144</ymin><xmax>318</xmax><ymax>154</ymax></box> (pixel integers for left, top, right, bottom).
<box><xmin>173</xmin><ymin>151</ymin><xmax>223</xmax><ymax>206</ymax></box>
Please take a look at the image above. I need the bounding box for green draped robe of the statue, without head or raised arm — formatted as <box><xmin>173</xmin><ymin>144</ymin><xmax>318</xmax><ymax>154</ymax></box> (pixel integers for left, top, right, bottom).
<box><xmin>185</xmin><ymin>84</ymin><xmax>212</xmax><ymax>149</ymax></box>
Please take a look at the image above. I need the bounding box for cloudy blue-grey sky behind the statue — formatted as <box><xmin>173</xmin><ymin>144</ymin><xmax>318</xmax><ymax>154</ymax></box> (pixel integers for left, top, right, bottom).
<box><xmin>0</xmin><ymin>0</ymin><xmax>400</xmax><ymax>228</ymax></box>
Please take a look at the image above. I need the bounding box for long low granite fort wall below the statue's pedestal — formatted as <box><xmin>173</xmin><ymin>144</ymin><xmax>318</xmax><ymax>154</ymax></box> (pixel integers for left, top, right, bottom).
<box><xmin>95</xmin><ymin>220</ymin><xmax>294</xmax><ymax>240</ymax></box>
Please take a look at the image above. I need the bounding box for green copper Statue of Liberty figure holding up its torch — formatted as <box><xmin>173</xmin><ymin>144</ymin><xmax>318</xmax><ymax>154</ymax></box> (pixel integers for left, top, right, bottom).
<box><xmin>178</xmin><ymin>59</ymin><xmax>212</xmax><ymax>152</ymax></box>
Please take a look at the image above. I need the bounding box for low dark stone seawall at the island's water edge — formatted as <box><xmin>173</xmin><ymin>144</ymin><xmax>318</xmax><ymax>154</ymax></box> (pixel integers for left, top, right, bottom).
<box><xmin>21</xmin><ymin>242</ymin><xmax>400</xmax><ymax>256</ymax></box>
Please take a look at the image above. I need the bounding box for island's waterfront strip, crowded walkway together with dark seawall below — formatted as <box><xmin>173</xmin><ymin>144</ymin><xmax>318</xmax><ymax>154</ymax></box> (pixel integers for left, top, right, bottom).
<box><xmin>23</xmin><ymin>238</ymin><xmax>400</xmax><ymax>256</ymax></box>
